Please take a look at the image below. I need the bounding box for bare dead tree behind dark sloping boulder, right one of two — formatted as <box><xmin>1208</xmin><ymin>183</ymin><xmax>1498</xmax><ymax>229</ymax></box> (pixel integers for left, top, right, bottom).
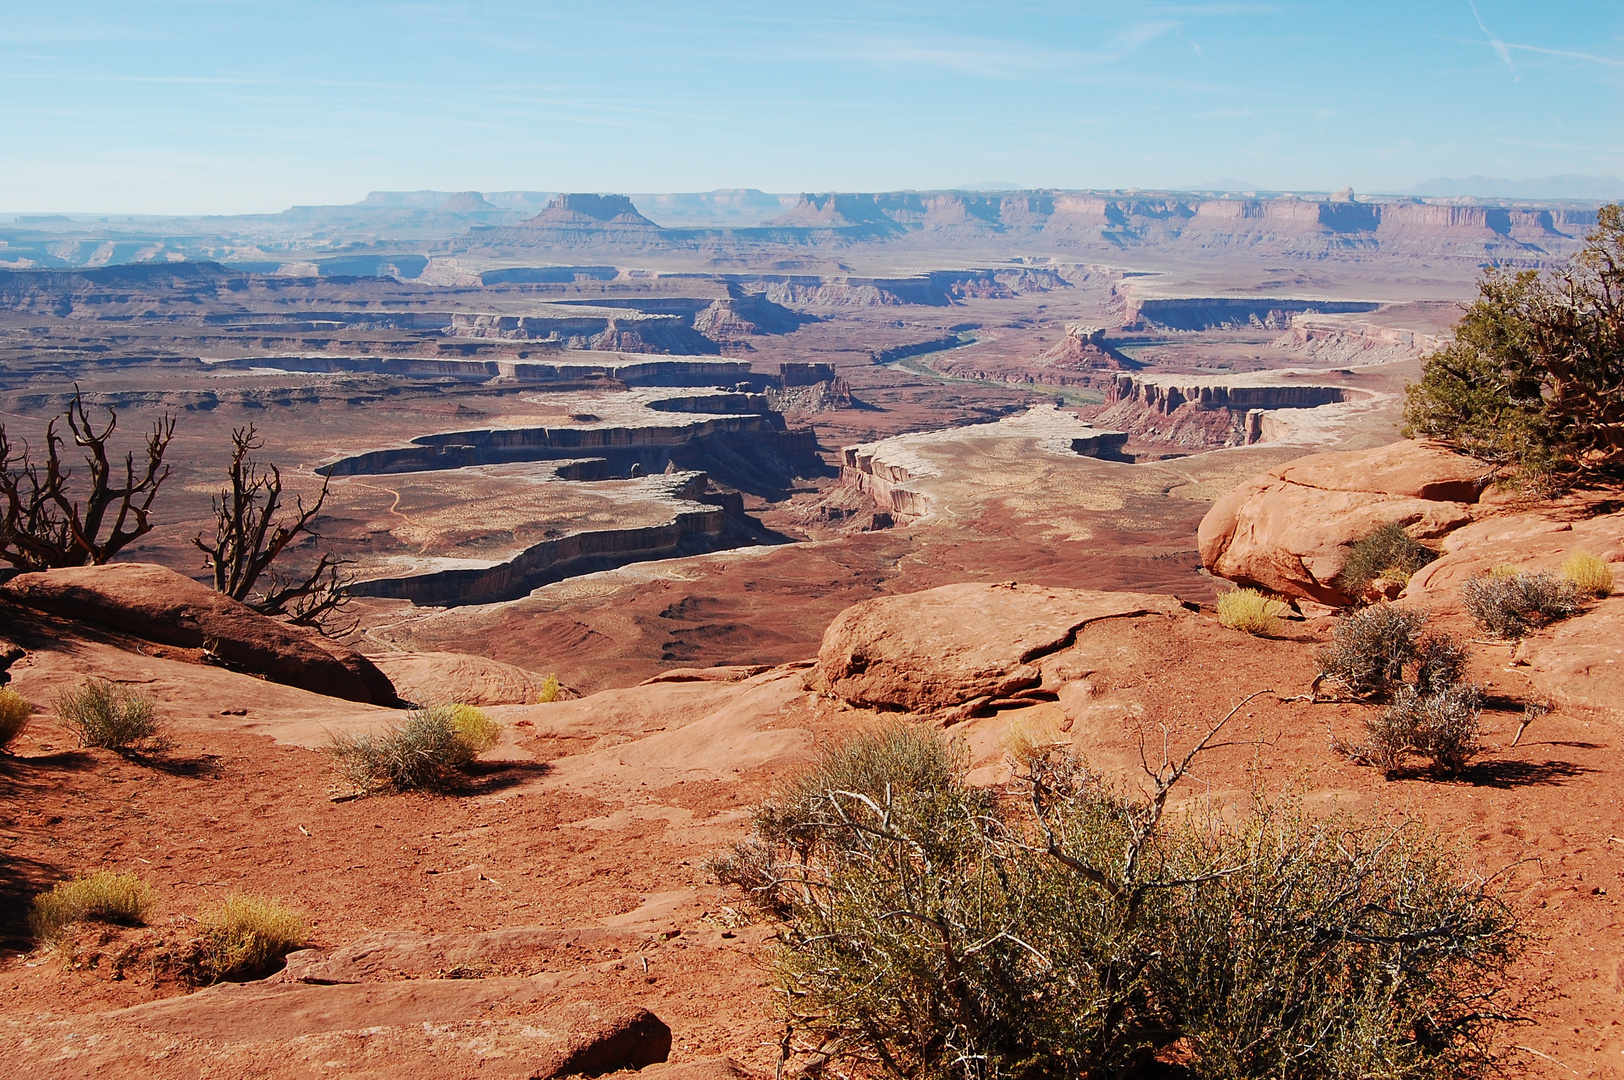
<box><xmin>192</xmin><ymin>424</ymin><xmax>352</xmax><ymax>632</ymax></box>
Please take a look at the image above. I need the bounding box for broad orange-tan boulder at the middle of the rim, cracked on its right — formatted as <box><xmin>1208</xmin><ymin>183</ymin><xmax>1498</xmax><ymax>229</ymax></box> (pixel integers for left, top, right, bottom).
<box><xmin>814</xmin><ymin>581</ymin><xmax>1181</xmax><ymax>711</ymax></box>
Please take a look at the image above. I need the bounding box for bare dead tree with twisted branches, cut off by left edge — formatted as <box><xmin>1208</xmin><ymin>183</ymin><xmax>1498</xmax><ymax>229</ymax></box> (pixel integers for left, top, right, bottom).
<box><xmin>0</xmin><ymin>387</ymin><xmax>175</xmax><ymax>570</ymax></box>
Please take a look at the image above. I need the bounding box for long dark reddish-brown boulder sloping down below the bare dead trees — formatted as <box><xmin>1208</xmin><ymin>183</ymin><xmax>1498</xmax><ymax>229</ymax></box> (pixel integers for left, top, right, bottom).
<box><xmin>0</xmin><ymin>562</ymin><xmax>400</xmax><ymax>705</ymax></box>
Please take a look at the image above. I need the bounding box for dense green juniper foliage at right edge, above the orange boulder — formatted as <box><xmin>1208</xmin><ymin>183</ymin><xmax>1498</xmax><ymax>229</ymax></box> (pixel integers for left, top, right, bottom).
<box><xmin>1405</xmin><ymin>203</ymin><xmax>1624</xmax><ymax>481</ymax></box>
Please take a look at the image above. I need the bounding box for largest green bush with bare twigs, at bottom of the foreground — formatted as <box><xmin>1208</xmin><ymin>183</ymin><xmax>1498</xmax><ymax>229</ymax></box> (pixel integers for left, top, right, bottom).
<box><xmin>713</xmin><ymin>713</ymin><xmax>1522</xmax><ymax>1080</ymax></box>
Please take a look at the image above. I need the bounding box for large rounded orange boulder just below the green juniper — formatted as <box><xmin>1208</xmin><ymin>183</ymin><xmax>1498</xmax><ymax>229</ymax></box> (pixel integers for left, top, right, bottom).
<box><xmin>1197</xmin><ymin>442</ymin><xmax>1491</xmax><ymax>607</ymax></box>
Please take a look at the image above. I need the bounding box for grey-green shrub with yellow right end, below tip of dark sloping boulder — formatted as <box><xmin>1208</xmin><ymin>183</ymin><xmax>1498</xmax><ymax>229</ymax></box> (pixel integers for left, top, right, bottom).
<box><xmin>328</xmin><ymin>705</ymin><xmax>500</xmax><ymax>794</ymax></box>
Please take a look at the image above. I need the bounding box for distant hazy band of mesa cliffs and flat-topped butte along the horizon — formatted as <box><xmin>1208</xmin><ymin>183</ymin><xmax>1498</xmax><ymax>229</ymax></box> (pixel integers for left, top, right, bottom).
<box><xmin>468</xmin><ymin>192</ymin><xmax>1595</xmax><ymax>260</ymax></box>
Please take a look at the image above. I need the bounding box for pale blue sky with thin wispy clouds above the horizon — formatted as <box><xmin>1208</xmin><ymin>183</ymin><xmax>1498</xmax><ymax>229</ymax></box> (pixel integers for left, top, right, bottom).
<box><xmin>0</xmin><ymin>0</ymin><xmax>1624</xmax><ymax>213</ymax></box>
